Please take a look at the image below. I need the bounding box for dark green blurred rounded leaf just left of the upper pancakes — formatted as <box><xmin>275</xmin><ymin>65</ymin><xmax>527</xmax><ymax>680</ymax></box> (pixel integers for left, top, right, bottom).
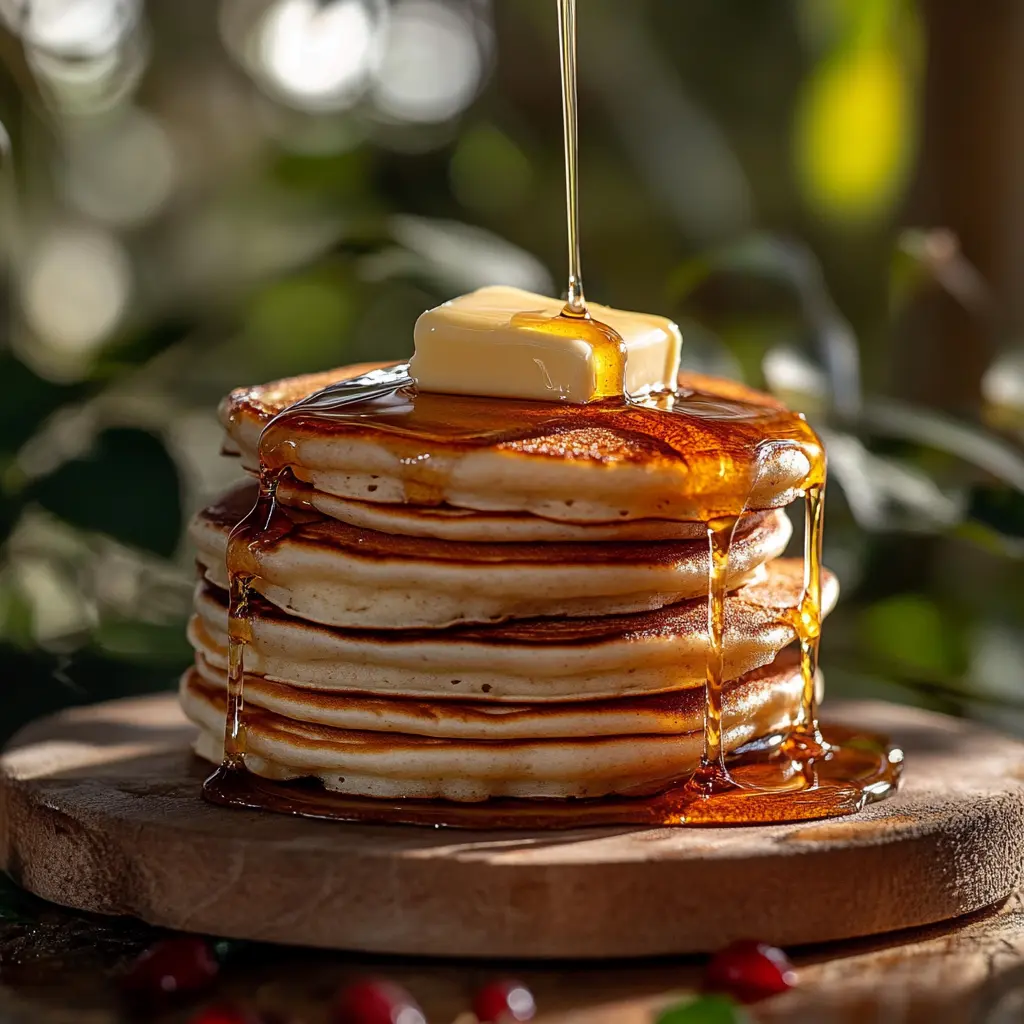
<box><xmin>31</xmin><ymin>427</ymin><xmax>182</xmax><ymax>557</ymax></box>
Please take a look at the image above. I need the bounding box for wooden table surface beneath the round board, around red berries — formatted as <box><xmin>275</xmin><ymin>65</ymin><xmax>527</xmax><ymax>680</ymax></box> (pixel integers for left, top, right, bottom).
<box><xmin>0</xmin><ymin>883</ymin><xmax>1024</xmax><ymax>1024</ymax></box>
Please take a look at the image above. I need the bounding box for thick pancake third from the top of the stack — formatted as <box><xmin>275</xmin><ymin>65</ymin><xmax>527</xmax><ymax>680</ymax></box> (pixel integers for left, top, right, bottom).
<box><xmin>191</xmin><ymin>483</ymin><xmax>792</xmax><ymax>629</ymax></box>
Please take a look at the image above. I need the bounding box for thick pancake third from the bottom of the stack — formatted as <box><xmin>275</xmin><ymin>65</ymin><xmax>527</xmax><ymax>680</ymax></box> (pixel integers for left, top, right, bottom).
<box><xmin>189</xmin><ymin>559</ymin><xmax>839</xmax><ymax>703</ymax></box>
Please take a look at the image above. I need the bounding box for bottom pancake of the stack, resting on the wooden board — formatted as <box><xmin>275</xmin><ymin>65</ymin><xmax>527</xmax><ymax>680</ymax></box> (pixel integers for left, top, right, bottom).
<box><xmin>180</xmin><ymin>670</ymin><xmax>800</xmax><ymax>802</ymax></box>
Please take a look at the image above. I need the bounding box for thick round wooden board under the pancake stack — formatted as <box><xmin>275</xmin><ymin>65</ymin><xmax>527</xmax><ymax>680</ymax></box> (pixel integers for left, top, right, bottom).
<box><xmin>0</xmin><ymin>694</ymin><xmax>1024</xmax><ymax>958</ymax></box>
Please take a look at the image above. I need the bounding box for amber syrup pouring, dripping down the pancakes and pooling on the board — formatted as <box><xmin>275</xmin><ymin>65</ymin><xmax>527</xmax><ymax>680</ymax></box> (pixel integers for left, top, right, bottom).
<box><xmin>197</xmin><ymin>0</ymin><xmax>902</xmax><ymax>828</ymax></box>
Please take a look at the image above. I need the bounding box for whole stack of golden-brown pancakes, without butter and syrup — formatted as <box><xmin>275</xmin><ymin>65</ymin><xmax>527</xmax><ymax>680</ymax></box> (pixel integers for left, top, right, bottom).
<box><xmin>181</xmin><ymin>367</ymin><xmax>837</xmax><ymax>802</ymax></box>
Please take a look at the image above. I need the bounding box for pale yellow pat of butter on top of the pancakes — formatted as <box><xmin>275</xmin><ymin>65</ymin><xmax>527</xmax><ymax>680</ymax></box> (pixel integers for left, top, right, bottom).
<box><xmin>410</xmin><ymin>287</ymin><xmax>682</xmax><ymax>404</ymax></box>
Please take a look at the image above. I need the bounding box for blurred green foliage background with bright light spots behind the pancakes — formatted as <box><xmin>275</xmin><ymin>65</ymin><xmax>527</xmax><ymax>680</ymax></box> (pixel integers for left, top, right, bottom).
<box><xmin>0</xmin><ymin>0</ymin><xmax>1024</xmax><ymax>734</ymax></box>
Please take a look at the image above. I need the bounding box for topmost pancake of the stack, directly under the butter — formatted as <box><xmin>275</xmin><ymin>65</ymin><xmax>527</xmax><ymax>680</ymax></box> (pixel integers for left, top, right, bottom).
<box><xmin>220</xmin><ymin>365</ymin><xmax>811</xmax><ymax>523</ymax></box>
